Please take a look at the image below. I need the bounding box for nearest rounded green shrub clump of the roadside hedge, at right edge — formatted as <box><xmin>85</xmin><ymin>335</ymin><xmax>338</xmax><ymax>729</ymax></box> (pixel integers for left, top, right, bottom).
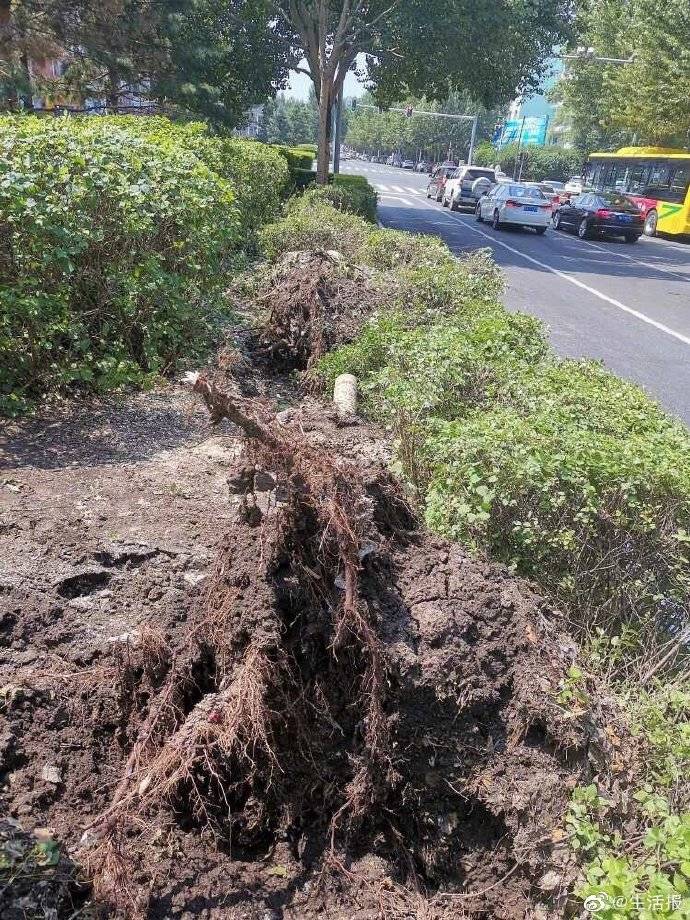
<box><xmin>422</xmin><ymin>361</ymin><xmax>690</xmax><ymax>639</ymax></box>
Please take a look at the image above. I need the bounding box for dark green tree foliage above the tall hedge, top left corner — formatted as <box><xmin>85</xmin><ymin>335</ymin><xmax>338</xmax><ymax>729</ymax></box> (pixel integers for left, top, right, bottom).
<box><xmin>0</xmin><ymin>0</ymin><xmax>295</xmax><ymax>127</ymax></box>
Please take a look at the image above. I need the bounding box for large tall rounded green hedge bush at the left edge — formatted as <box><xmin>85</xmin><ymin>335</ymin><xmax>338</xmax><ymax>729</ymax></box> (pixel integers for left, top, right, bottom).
<box><xmin>0</xmin><ymin>118</ymin><xmax>244</xmax><ymax>412</ymax></box>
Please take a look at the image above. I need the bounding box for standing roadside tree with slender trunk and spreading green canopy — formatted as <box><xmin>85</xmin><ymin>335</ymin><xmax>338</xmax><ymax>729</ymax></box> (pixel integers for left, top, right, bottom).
<box><xmin>260</xmin><ymin>0</ymin><xmax>571</xmax><ymax>183</ymax></box>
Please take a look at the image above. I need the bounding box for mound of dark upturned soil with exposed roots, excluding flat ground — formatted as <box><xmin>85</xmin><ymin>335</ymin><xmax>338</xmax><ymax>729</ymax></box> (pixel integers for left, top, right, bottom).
<box><xmin>3</xmin><ymin>381</ymin><xmax>620</xmax><ymax>920</ymax></box>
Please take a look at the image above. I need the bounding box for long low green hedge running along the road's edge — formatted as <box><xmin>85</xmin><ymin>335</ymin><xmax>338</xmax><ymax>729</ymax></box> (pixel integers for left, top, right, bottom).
<box><xmin>310</xmin><ymin>199</ymin><xmax>690</xmax><ymax>654</ymax></box>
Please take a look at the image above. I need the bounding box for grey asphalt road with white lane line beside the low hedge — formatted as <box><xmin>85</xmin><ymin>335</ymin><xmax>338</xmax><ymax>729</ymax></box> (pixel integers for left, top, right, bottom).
<box><xmin>342</xmin><ymin>160</ymin><xmax>690</xmax><ymax>424</ymax></box>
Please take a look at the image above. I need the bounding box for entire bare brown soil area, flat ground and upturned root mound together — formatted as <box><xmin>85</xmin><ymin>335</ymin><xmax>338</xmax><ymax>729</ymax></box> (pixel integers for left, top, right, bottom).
<box><xmin>0</xmin><ymin>253</ymin><xmax>624</xmax><ymax>920</ymax></box>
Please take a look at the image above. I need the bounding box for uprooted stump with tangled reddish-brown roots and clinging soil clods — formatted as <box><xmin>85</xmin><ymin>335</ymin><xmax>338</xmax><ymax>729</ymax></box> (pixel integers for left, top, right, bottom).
<box><xmin>83</xmin><ymin>377</ymin><xmax>620</xmax><ymax>918</ymax></box>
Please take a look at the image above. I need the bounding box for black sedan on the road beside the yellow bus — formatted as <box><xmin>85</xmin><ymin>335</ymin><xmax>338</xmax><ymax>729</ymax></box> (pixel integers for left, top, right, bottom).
<box><xmin>553</xmin><ymin>192</ymin><xmax>644</xmax><ymax>243</ymax></box>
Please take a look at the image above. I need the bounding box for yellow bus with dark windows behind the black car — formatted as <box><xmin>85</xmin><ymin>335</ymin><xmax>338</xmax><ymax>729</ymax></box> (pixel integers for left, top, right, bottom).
<box><xmin>585</xmin><ymin>147</ymin><xmax>690</xmax><ymax>236</ymax></box>
